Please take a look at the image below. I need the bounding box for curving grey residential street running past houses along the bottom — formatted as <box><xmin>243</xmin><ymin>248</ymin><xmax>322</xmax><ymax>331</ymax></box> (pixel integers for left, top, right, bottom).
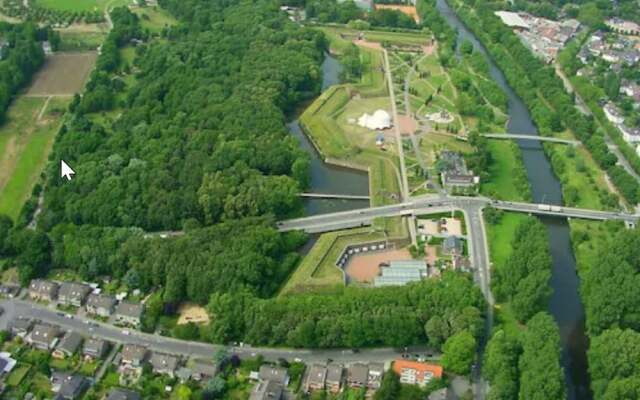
<box><xmin>0</xmin><ymin>299</ymin><xmax>418</xmax><ymax>364</ymax></box>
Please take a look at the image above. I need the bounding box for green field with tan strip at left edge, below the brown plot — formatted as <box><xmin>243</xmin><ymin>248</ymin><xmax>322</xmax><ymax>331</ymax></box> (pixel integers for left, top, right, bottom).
<box><xmin>0</xmin><ymin>97</ymin><xmax>70</xmax><ymax>219</ymax></box>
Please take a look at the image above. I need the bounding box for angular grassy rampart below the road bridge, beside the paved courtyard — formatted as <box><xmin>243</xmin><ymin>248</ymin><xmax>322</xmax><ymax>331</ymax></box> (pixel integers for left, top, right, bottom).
<box><xmin>280</xmin><ymin>228</ymin><xmax>384</xmax><ymax>295</ymax></box>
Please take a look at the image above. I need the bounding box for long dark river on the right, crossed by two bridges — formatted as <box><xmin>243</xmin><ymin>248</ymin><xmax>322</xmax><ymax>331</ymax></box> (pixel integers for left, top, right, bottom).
<box><xmin>437</xmin><ymin>0</ymin><xmax>592</xmax><ymax>400</ymax></box>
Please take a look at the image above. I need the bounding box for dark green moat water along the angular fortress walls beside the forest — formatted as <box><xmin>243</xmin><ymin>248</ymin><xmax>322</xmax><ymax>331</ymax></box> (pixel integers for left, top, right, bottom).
<box><xmin>287</xmin><ymin>54</ymin><xmax>369</xmax><ymax>215</ymax></box>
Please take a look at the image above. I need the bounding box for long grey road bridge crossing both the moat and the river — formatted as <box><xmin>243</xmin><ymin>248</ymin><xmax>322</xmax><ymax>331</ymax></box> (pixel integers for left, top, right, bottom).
<box><xmin>277</xmin><ymin>196</ymin><xmax>640</xmax><ymax>233</ymax></box>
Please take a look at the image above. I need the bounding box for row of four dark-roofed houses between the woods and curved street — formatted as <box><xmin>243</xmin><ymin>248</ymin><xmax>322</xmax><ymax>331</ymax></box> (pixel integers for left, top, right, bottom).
<box><xmin>28</xmin><ymin>279</ymin><xmax>144</xmax><ymax>327</ymax></box>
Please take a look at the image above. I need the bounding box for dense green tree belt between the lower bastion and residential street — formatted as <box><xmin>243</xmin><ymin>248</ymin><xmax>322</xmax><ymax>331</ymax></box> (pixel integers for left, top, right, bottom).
<box><xmin>208</xmin><ymin>272</ymin><xmax>484</xmax><ymax>350</ymax></box>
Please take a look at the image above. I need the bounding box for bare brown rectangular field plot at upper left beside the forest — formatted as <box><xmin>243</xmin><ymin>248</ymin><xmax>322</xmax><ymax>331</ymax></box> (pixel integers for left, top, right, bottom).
<box><xmin>26</xmin><ymin>52</ymin><xmax>98</xmax><ymax>96</ymax></box>
